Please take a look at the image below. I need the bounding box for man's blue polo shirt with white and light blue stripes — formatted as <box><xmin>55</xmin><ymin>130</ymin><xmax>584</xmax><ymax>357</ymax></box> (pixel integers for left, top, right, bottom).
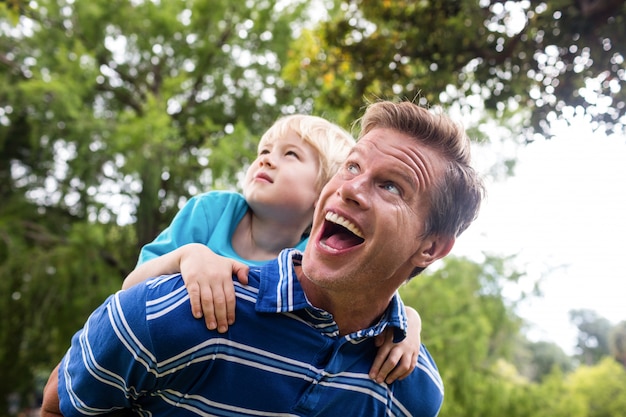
<box><xmin>59</xmin><ymin>250</ymin><xmax>443</xmax><ymax>417</ymax></box>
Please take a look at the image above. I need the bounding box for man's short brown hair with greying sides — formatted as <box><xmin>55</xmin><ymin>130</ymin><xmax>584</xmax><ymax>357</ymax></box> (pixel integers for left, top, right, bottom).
<box><xmin>361</xmin><ymin>101</ymin><xmax>485</xmax><ymax>237</ymax></box>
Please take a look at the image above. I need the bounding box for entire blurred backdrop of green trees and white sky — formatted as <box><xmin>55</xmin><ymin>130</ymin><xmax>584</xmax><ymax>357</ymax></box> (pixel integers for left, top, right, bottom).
<box><xmin>0</xmin><ymin>0</ymin><xmax>626</xmax><ymax>417</ymax></box>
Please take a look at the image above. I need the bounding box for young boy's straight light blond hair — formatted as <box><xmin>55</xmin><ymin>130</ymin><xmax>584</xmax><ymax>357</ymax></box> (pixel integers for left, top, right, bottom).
<box><xmin>259</xmin><ymin>114</ymin><xmax>355</xmax><ymax>190</ymax></box>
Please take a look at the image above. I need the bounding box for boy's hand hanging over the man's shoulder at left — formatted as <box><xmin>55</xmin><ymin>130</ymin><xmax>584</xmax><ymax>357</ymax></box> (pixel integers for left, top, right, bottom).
<box><xmin>180</xmin><ymin>244</ymin><xmax>249</xmax><ymax>333</ymax></box>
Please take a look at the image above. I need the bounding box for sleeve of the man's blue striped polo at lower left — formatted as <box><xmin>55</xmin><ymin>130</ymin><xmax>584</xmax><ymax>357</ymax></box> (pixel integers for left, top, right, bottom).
<box><xmin>58</xmin><ymin>285</ymin><xmax>157</xmax><ymax>417</ymax></box>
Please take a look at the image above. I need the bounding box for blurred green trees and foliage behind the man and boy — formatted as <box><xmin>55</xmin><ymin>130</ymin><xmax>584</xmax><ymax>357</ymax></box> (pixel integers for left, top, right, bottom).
<box><xmin>0</xmin><ymin>0</ymin><xmax>626</xmax><ymax>417</ymax></box>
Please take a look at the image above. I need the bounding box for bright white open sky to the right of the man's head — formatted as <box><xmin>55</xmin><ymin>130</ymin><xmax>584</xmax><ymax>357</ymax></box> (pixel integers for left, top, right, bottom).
<box><xmin>453</xmin><ymin>118</ymin><xmax>626</xmax><ymax>354</ymax></box>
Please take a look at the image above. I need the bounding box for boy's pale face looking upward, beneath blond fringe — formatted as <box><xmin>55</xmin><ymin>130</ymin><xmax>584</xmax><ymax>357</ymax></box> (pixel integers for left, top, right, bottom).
<box><xmin>243</xmin><ymin>130</ymin><xmax>320</xmax><ymax>223</ymax></box>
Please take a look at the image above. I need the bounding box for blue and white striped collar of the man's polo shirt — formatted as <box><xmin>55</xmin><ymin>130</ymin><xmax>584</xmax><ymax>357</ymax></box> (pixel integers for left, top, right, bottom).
<box><xmin>256</xmin><ymin>249</ymin><xmax>407</xmax><ymax>342</ymax></box>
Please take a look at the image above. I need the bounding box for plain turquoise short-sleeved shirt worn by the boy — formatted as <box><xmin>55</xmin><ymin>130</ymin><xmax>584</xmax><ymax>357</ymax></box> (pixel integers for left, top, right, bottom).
<box><xmin>137</xmin><ymin>191</ymin><xmax>308</xmax><ymax>266</ymax></box>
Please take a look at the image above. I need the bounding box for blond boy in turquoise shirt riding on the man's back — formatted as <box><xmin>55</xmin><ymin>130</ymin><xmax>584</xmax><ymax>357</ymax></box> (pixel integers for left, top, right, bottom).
<box><xmin>123</xmin><ymin>115</ymin><xmax>421</xmax><ymax>383</ymax></box>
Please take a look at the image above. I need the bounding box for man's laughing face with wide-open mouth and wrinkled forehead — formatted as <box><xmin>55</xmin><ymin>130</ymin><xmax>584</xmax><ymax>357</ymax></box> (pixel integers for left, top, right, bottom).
<box><xmin>303</xmin><ymin>128</ymin><xmax>449</xmax><ymax>296</ymax></box>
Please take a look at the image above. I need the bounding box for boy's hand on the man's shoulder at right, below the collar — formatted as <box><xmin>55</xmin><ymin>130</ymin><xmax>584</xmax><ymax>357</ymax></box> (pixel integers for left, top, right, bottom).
<box><xmin>369</xmin><ymin>307</ymin><xmax>422</xmax><ymax>384</ymax></box>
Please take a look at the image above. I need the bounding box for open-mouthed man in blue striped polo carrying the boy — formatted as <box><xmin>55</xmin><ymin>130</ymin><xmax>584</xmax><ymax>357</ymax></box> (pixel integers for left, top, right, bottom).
<box><xmin>43</xmin><ymin>102</ymin><xmax>483</xmax><ymax>417</ymax></box>
